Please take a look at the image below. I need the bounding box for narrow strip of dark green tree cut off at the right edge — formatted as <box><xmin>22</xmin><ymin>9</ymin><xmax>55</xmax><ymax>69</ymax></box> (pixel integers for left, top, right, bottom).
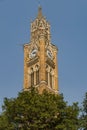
<box><xmin>80</xmin><ymin>92</ymin><xmax>87</xmax><ymax>130</ymax></box>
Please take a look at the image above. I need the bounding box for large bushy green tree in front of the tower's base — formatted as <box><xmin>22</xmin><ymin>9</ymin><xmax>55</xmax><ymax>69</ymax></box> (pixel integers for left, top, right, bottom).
<box><xmin>2</xmin><ymin>89</ymin><xmax>79</xmax><ymax>130</ymax></box>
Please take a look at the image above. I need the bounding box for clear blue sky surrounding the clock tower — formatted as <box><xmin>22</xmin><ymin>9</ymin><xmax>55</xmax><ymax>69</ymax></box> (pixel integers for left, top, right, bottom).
<box><xmin>0</xmin><ymin>0</ymin><xmax>87</xmax><ymax>111</ymax></box>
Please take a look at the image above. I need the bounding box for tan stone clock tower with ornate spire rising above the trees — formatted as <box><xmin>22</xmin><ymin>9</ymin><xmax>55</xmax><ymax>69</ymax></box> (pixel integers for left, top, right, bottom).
<box><xmin>23</xmin><ymin>7</ymin><xmax>58</xmax><ymax>93</ymax></box>
